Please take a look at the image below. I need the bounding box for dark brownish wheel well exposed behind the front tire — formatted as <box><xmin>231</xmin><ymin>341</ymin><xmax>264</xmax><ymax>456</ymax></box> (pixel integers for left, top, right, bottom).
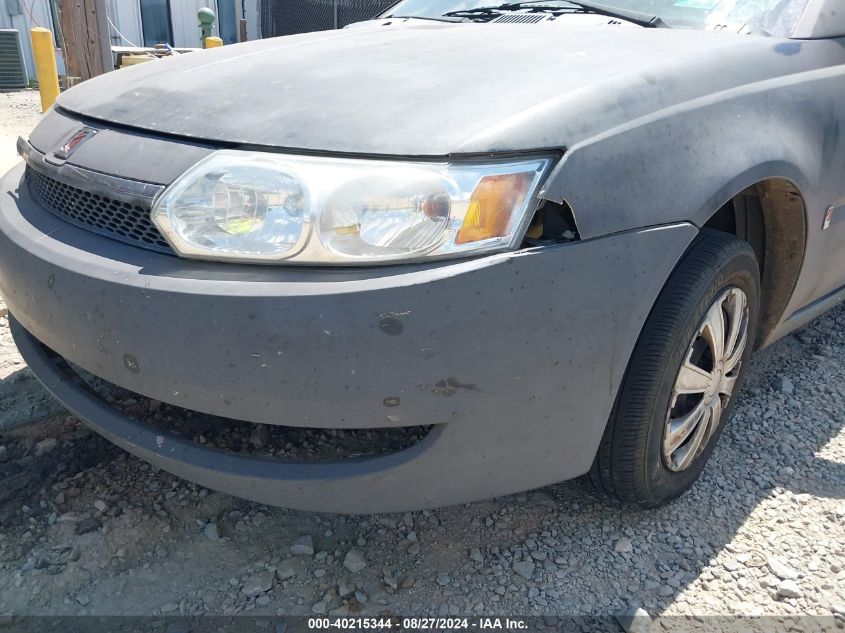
<box><xmin>705</xmin><ymin>178</ymin><xmax>807</xmax><ymax>345</ymax></box>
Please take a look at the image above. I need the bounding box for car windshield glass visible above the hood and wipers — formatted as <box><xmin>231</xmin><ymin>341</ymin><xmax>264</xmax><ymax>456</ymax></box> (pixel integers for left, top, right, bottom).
<box><xmin>385</xmin><ymin>0</ymin><xmax>808</xmax><ymax>37</ymax></box>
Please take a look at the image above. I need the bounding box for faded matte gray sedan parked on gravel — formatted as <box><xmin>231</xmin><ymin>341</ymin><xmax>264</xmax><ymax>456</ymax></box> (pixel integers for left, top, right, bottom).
<box><xmin>0</xmin><ymin>0</ymin><xmax>845</xmax><ymax>512</ymax></box>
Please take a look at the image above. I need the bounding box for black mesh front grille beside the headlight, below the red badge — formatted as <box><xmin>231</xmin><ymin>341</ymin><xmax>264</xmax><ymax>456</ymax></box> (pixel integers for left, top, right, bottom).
<box><xmin>26</xmin><ymin>166</ymin><xmax>173</xmax><ymax>255</ymax></box>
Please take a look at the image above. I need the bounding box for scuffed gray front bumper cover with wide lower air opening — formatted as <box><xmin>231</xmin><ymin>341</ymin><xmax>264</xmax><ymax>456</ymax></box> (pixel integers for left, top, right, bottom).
<box><xmin>0</xmin><ymin>160</ymin><xmax>696</xmax><ymax>512</ymax></box>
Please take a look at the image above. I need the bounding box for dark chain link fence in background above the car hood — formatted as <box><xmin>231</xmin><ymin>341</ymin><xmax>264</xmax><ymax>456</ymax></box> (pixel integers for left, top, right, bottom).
<box><xmin>261</xmin><ymin>0</ymin><xmax>396</xmax><ymax>37</ymax></box>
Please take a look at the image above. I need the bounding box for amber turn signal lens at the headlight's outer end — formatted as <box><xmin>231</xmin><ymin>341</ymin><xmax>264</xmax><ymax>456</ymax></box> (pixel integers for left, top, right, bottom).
<box><xmin>455</xmin><ymin>172</ymin><xmax>535</xmax><ymax>244</ymax></box>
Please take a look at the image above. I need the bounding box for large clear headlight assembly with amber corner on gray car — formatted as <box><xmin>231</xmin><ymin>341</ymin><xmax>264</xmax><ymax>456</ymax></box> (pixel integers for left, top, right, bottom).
<box><xmin>152</xmin><ymin>150</ymin><xmax>550</xmax><ymax>264</ymax></box>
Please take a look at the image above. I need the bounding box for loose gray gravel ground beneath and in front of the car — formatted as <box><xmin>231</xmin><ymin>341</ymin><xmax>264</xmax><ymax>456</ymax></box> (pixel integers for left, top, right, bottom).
<box><xmin>0</xmin><ymin>89</ymin><xmax>845</xmax><ymax>630</ymax></box>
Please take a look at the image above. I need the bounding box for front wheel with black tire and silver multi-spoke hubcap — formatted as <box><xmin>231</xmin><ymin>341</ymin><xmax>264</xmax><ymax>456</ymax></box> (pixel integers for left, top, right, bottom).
<box><xmin>589</xmin><ymin>229</ymin><xmax>760</xmax><ymax>508</ymax></box>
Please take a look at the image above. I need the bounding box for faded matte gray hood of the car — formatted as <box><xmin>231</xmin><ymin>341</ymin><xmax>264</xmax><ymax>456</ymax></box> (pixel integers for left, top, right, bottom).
<box><xmin>58</xmin><ymin>21</ymin><xmax>800</xmax><ymax>156</ymax></box>
